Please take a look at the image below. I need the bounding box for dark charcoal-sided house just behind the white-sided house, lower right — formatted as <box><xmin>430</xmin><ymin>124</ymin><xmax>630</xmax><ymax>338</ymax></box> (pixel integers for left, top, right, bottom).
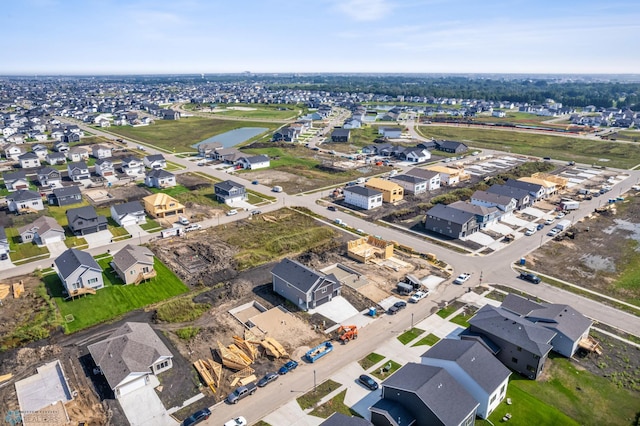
<box><xmin>460</xmin><ymin>305</ymin><xmax>556</xmax><ymax>379</ymax></box>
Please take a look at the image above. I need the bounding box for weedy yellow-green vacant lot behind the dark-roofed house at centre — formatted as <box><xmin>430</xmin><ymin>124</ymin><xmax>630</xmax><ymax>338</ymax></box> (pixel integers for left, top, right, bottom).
<box><xmin>216</xmin><ymin>209</ymin><xmax>336</xmax><ymax>270</ymax></box>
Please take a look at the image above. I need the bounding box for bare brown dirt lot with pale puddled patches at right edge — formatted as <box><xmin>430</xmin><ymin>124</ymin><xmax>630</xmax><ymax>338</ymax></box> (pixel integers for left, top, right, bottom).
<box><xmin>526</xmin><ymin>188</ymin><xmax>640</xmax><ymax>305</ymax></box>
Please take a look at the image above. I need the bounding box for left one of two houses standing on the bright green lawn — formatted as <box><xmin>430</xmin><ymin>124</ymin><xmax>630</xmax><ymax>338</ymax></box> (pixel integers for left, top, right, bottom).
<box><xmin>54</xmin><ymin>248</ymin><xmax>104</xmax><ymax>296</ymax></box>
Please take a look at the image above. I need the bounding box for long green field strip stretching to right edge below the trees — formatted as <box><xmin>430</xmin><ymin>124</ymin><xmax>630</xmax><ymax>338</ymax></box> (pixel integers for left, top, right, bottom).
<box><xmin>417</xmin><ymin>125</ymin><xmax>640</xmax><ymax>169</ymax></box>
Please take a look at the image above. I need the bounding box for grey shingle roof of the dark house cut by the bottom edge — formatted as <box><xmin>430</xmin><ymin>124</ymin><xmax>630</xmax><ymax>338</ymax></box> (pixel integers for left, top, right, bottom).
<box><xmin>382</xmin><ymin>363</ymin><xmax>479</xmax><ymax>425</ymax></box>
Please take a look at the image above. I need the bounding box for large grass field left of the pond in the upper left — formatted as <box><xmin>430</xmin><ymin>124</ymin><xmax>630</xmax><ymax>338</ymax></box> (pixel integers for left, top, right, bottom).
<box><xmin>109</xmin><ymin>117</ymin><xmax>278</xmax><ymax>152</ymax></box>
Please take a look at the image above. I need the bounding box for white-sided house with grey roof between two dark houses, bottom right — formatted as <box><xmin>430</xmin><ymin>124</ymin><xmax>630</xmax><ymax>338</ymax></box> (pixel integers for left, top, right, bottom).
<box><xmin>421</xmin><ymin>339</ymin><xmax>511</xmax><ymax>419</ymax></box>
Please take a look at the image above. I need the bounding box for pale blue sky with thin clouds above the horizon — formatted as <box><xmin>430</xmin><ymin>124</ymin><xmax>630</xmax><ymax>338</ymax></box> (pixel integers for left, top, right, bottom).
<box><xmin>0</xmin><ymin>0</ymin><xmax>640</xmax><ymax>74</ymax></box>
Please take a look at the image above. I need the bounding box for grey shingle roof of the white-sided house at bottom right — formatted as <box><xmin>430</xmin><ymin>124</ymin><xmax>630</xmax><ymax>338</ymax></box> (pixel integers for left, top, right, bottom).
<box><xmin>422</xmin><ymin>339</ymin><xmax>511</xmax><ymax>394</ymax></box>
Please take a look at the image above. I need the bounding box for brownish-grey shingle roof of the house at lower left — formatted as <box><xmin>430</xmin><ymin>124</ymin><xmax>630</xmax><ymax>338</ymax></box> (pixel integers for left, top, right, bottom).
<box><xmin>87</xmin><ymin>322</ymin><xmax>173</xmax><ymax>389</ymax></box>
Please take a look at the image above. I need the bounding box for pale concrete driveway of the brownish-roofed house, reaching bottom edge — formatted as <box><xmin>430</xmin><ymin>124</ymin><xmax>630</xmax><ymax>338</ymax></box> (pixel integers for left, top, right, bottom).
<box><xmin>119</xmin><ymin>376</ymin><xmax>178</xmax><ymax>426</ymax></box>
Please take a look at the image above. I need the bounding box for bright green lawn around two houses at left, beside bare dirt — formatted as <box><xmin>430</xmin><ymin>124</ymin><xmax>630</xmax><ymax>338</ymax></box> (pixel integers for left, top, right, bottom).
<box><xmin>43</xmin><ymin>257</ymin><xmax>189</xmax><ymax>333</ymax></box>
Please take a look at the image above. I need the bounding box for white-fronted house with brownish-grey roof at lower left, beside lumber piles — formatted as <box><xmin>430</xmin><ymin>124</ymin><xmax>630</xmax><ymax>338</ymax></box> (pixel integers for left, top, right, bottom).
<box><xmin>87</xmin><ymin>322</ymin><xmax>173</xmax><ymax>398</ymax></box>
